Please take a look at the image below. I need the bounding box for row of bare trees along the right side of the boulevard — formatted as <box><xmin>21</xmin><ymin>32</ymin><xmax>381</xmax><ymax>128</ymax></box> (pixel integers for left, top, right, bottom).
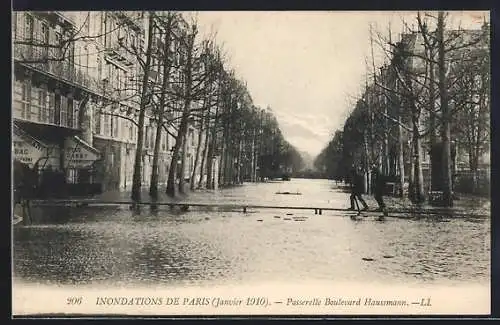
<box><xmin>317</xmin><ymin>12</ymin><xmax>490</xmax><ymax>206</ymax></box>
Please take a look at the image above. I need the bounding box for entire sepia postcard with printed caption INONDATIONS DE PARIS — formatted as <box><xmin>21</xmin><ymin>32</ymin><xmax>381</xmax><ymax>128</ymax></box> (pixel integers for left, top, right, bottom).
<box><xmin>11</xmin><ymin>11</ymin><xmax>491</xmax><ymax>317</ymax></box>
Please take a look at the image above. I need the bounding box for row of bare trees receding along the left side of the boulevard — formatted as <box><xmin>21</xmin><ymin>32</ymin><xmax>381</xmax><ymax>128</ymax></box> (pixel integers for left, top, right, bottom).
<box><xmin>123</xmin><ymin>12</ymin><xmax>304</xmax><ymax>200</ymax></box>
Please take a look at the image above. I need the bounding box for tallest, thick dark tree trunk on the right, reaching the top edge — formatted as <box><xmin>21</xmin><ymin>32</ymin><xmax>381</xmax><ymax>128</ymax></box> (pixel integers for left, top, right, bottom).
<box><xmin>437</xmin><ymin>11</ymin><xmax>453</xmax><ymax>207</ymax></box>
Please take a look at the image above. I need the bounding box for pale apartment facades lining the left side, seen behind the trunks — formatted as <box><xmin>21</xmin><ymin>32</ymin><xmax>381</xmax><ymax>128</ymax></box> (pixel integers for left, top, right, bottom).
<box><xmin>12</xmin><ymin>11</ymin><xmax>205</xmax><ymax>195</ymax></box>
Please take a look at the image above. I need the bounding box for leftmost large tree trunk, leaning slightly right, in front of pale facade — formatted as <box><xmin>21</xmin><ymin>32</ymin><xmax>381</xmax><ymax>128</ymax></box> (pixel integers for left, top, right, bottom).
<box><xmin>131</xmin><ymin>13</ymin><xmax>154</xmax><ymax>202</ymax></box>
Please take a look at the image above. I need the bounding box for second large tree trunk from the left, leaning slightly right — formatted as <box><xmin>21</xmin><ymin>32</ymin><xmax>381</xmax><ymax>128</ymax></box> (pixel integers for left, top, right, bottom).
<box><xmin>149</xmin><ymin>13</ymin><xmax>173</xmax><ymax>199</ymax></box>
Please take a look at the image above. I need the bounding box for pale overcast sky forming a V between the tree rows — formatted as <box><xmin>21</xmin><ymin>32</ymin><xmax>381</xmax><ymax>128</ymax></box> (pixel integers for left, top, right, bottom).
<box><xmin>194</xmin><ymin>11</ymin><xmax>489</xmax><ymax>156</ymax></box>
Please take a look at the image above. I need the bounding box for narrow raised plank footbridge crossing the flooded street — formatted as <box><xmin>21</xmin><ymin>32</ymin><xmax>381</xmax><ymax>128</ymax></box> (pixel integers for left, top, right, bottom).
<box><xmin>32</xmin><ymin>200</ymin><xmax>491</xmax><ymax>218</ymax></box>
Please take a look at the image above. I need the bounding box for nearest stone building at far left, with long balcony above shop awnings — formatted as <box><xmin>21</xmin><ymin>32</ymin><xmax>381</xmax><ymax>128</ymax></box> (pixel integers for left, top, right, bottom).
<box><xmin>12</xmin><ymin>12</ymin><xmax>100</xmax><ymax>194</ymax></box>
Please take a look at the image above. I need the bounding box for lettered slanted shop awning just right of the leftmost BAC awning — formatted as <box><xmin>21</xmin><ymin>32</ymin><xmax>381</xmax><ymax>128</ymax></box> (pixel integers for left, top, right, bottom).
<box><xmin>64</xmin><ymin>137</ymin><xmax>100</xmax><ymax>168</ymax></box>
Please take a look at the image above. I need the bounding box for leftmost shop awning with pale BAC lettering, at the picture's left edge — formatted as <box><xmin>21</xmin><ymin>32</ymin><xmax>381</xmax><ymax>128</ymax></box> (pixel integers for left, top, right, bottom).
<box><xmin>12</xmin><ymin>128</ymin><xmax>47</xmax><ymax>167</ymax></box>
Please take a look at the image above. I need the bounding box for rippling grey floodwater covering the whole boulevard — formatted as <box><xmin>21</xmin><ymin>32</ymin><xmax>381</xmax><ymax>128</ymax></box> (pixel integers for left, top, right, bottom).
<box><xmin>13</xmin><ymin>179</ymin><xmax>490</xmax><ymax>287</ymax></box>
